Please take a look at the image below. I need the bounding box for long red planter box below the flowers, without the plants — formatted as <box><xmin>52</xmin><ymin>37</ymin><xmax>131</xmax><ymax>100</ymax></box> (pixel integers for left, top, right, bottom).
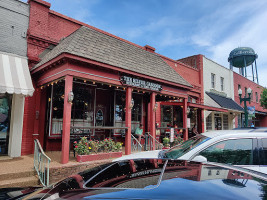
<box><xmin>76</xmin><ymin>151</ymin><xmax>122</xmax><ymax>162</ymax></box>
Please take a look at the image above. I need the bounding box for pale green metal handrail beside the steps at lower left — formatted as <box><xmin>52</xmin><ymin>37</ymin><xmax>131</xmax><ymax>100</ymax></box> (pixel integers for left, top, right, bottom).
<box><xmin>34</xmin><ymin>139</ymin><xmax>51</xmax><ymax>186</ymax></box>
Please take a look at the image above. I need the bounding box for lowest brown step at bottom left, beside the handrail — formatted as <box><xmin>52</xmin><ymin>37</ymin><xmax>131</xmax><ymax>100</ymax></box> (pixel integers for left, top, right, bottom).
<box><xmin>0</xmin><ymin>176</ymin><xmax>40</xmax><ymax>188</ymax></box>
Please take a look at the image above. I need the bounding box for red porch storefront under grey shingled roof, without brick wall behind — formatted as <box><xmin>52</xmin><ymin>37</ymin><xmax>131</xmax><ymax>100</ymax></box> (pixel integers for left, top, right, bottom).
<box><xmin>28</xmin><ymin>27</ymin><xmax>192</xmax><ymax>163</ymax></box>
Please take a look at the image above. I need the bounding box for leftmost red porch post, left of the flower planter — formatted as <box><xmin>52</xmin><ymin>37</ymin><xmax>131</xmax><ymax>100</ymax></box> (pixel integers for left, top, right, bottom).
<box><xmin>61</xmin><ymin>75</ymin><xmax>75</xmax><ymax>164</ymax></box>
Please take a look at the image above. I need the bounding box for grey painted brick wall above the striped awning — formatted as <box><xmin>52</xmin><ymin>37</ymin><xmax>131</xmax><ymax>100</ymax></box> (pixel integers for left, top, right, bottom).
<box><xmin>0</xmin><ymin>0</ymin><xmax>29</xmax><ymax>57</ymax></box>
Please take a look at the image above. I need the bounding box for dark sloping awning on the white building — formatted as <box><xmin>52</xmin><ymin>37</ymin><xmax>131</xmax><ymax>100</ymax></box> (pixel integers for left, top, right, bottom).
<box><xmin>206</xmin><ymin>92</ymin><xmax>244</xmax><ymax>112</ymax></box>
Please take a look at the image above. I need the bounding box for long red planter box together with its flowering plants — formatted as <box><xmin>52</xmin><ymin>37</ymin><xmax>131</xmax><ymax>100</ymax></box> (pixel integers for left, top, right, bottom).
<box><xmin>74</xmin><ymin>137</ymin><xmax>122</xmax><ymax>162</ymax></box>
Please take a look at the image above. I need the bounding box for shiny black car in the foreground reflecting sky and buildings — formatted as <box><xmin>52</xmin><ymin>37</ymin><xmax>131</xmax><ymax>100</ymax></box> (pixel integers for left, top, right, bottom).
<box><xmin>0</xmin><ymin>159</ymin><xmax>267</xmax><ymax>200</ymax></box>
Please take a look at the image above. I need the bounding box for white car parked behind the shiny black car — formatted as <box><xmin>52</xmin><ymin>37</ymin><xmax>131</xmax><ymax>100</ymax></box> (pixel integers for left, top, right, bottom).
<box><xmin>115</xmin><ymin>129</ymin><xmax>267</xmax><ymax>174</ymax></box>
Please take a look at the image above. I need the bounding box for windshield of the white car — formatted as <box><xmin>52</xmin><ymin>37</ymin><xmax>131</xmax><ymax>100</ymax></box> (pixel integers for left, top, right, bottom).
<box><xmin>163</xmin><ymin>135</ymin><xmax>211</xmax><ymax>159</ymax></box>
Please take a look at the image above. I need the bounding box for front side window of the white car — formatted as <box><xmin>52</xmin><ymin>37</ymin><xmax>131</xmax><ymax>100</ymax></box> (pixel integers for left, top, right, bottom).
<box><xmin>199</xmin><ymin>139</ymin><xmax>253</xmax><ymax>165</ymax></box>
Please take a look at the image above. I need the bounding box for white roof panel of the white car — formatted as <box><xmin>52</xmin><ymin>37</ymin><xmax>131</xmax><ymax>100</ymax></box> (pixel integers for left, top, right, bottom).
<box><xmin>202</xmin><ymin>128</ymin><xmax>267</xmax><ymax>138</ymax></box>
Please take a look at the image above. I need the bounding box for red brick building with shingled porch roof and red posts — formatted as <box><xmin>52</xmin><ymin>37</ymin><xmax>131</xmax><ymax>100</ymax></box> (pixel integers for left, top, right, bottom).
<box><xmin>22</xmin><ymin>0</ymin><xmax>211</xmax><ymax>163</ymax></box>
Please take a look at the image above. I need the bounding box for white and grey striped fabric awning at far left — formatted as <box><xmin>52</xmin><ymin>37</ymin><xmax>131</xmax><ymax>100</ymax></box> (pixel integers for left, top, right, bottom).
<box><xmin>0</xmin><ymin>53</ymin><xmax>34</xmax><ymax>96</ymax></box>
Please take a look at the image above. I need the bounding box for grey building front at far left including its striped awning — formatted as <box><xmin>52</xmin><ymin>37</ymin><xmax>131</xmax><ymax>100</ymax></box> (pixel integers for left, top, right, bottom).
<box><xmin>0</xmin><ymin>0</ymin><xmax>34</xmax><ymax>157</ymax></box>
